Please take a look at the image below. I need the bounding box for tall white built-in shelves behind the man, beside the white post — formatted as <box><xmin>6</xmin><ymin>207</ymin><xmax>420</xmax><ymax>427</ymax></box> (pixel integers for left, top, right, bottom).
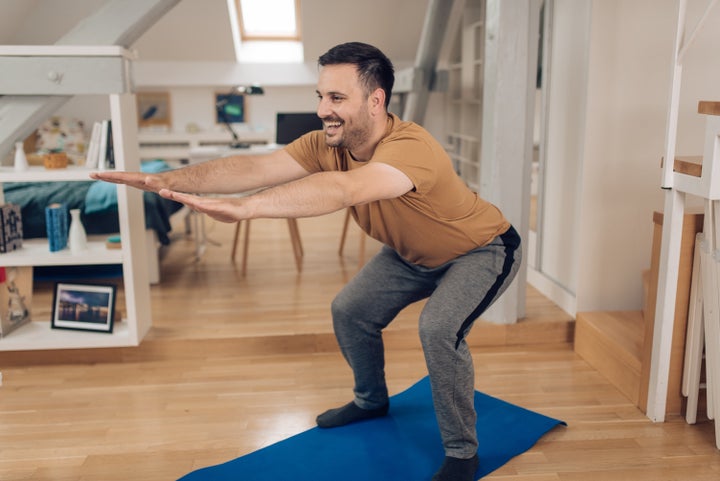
<box><xmin>446</xmin><ymin>0</ymin><xmax>485</xmax><ymax>191</ymax></box>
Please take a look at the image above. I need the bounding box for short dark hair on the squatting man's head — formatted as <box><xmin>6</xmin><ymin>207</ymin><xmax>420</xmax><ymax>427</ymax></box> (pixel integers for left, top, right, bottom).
<box><xmin>318</xmin><ymin>42</ymin><xmax>395</xmax><ymax>109</ymax></box>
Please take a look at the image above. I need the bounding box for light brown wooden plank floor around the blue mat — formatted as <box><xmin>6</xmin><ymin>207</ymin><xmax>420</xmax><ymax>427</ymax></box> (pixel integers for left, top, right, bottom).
<box><xmin>0</xmin><ymin>214</ymin><xmax>720</xmax><ymax>481</ymax></box>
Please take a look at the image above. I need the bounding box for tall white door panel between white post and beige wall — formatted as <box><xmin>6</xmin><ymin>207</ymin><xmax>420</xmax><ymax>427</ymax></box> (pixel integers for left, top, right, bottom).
<box><xmin>537</xmin><ymin>0</ymin><xmax>591</xmax><ymax>300</ymax></box>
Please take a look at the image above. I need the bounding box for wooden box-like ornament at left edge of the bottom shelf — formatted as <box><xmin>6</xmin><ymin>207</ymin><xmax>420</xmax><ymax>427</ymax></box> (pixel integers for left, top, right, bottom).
<box><xmin>0</xmin><ymin>267</ymin><xmax>33</xmax><ymax>338</ymax></box>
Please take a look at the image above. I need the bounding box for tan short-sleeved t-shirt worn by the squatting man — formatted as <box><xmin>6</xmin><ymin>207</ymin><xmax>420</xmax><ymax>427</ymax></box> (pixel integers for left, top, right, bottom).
<box><xmin>285</xmin><ymin>114</ymin><xmax>510</xmax><ymax>267</ymax></box>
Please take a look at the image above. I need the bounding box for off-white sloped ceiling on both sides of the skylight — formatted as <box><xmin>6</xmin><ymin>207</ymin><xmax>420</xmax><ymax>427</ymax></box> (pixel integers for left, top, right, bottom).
<box><xmin>0</xmin><ymin>0</ymin><xmax>429</xmax><ymax>63</ymax></box>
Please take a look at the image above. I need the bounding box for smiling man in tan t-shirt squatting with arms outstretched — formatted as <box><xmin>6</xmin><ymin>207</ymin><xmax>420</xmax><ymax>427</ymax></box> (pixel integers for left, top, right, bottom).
<box><xmin>92</xmin><ymin>42</ymin><xmax>520</xmax><ymax>481</ymax></box>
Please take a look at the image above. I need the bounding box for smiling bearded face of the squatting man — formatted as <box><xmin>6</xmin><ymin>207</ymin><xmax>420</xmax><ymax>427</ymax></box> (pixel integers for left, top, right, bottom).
<box><xmin>317</xmin><ymin>64</ymin><xmax>372</xmax><ymax>151</ymax></box>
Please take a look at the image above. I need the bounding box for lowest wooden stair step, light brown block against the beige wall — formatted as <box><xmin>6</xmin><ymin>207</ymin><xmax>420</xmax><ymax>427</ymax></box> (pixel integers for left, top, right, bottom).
<box><xmin>575</xmin><ymin>311</ymin><xmax>644</xmax><ymax>405</ymax></box>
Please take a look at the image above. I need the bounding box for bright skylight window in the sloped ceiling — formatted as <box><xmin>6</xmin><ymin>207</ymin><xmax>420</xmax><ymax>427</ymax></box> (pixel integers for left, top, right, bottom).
<box><xmin>236</xmin><ymin>0</ymin><xmax>300</xmax><ymax>41</ymax></box>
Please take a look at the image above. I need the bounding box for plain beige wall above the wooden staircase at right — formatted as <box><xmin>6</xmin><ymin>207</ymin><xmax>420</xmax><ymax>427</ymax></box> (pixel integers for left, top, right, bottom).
<box><xmin>577</xmin><ymin>0</ymin><xmax>720</xmax><ymax>311</ymax></box>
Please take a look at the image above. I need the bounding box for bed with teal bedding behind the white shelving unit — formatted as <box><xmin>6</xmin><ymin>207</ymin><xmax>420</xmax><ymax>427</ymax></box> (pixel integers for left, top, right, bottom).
<box><xmin>3</xmin><ymin>161</ymin><xmax>183</xmax><ymax>283</ymax></box>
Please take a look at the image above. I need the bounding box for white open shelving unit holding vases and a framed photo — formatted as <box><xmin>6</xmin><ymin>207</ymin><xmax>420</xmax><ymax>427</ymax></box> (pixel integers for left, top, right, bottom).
<box><xmin>0</xmin><ymin>46</ymin><xmax>152</xmax><ymax>351</ymax></box>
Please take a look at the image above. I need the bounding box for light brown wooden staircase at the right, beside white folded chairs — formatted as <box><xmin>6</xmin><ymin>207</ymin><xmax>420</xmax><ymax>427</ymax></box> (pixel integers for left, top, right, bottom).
<box><xmin>575</xmin><ymin>208</ymin><xmax>703</xmax><ymax>414</ymax></box>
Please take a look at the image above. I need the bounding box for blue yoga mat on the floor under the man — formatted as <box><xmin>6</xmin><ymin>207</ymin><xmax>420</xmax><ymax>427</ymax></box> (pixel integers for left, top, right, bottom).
<box><xmin>180</xmin><ymin>377</ymin><xmax>565</xmax><ymax>481</ymax></box>
